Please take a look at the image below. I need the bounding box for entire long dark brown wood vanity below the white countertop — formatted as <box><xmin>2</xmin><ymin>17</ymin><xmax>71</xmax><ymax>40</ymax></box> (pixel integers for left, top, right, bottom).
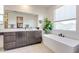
<box><xmin>4</xmin><ymin>30</ymin><xmax>42</xmax><ymax>50</ymax></box>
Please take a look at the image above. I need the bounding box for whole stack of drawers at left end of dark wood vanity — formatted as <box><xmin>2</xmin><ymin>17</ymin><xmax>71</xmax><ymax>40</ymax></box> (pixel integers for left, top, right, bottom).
<box><xmin>4</xmin><ymin>32</ymin><xmax>16</xmax><ymax>50</ymax></box>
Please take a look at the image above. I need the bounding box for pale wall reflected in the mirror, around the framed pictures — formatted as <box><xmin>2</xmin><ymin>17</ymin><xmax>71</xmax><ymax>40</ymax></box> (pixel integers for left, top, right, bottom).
<box><xmin>8</xmin><ymin>12</ymin><xmax>37</xmax><ymax>28</ymax></box>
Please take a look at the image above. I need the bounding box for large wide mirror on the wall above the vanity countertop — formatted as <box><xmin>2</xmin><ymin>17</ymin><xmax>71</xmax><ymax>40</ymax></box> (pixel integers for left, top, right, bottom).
<box><xmin>4</xmin><ymin>10</ymin><xmax>38</xmax><ymax>28</ymax></box>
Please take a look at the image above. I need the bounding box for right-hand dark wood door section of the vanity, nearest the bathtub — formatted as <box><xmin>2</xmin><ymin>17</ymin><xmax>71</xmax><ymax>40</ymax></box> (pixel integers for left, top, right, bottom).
<box><xmin>27</xmin><ymin>31</ymin><xmax>42</xmax><ymax>44</ymax></box>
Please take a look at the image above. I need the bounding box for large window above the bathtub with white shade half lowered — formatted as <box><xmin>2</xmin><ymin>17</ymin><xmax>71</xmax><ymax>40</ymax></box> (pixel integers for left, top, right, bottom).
<box><xmin>54</xmin><ymin>5</ymin><xmax>76</xmax><ymax>31</ymax></box>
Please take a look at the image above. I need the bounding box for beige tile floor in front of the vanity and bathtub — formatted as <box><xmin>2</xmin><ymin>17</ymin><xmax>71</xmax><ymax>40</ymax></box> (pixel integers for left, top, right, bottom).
<box><xmin>0</xmin><ymin>43</ymin><xmax>53</xmax><ymax>53</ymax></box>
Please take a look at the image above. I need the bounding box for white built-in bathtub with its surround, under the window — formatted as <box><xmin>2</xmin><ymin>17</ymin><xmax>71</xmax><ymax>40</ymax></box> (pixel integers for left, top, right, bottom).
<box><xmin>43</xmin><ymin>34</ymin><xmax>79</xmax><ymax>53</ymax></box>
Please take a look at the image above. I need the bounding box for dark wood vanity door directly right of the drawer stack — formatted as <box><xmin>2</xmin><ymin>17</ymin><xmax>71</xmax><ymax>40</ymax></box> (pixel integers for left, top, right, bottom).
<box><xmin>16</xmin><ymin>32</ymin><xmax>28</xmax><ymax>47</ymax></box>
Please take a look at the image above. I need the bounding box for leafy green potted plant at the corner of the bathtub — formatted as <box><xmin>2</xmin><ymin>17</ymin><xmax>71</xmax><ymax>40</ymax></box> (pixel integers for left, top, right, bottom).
<box><xmin>43</xmin><ymin>18</ymin><xmax>53</xmax><ymax>33</ymax></box>
